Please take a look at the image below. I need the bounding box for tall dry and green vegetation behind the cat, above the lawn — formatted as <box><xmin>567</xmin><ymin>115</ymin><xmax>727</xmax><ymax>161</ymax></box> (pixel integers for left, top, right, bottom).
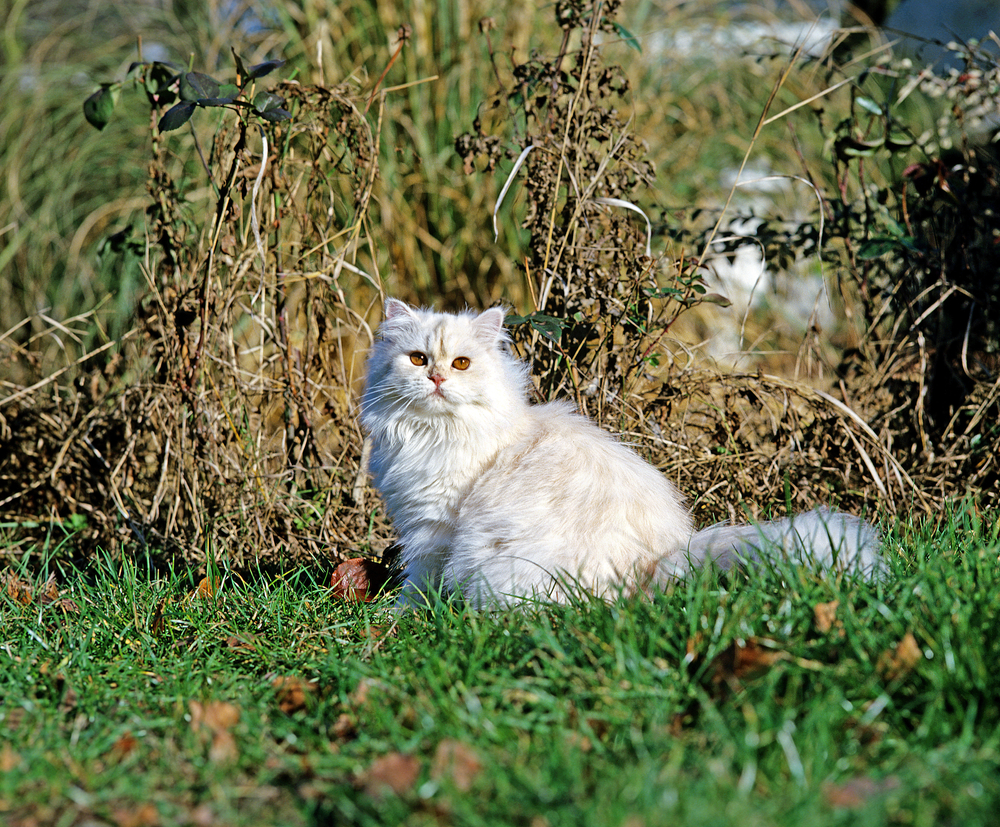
<box><xmin>0</xmin><ymin>2</ymin><xmax>1000</xmax><ymax>565</ymax></box>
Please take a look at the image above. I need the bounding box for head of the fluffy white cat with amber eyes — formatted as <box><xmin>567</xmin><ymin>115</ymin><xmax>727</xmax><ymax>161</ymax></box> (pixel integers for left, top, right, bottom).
<box><xmin>362</xmin><ymin>299</ymin><xmax>526</xmax><ymax>428</ymax></box>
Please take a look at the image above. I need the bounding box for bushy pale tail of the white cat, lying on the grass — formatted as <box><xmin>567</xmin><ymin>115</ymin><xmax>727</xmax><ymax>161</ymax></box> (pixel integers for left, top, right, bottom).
<box><xmin>654</xmin><ymin>508</ymin><xmax>885</xmax><ymax>583</ymax></box>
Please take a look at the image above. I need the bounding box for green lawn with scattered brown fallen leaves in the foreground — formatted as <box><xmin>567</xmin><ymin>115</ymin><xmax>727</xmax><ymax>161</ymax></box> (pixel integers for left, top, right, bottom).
<box><xmin>0</xmin><ymin>511</ymin><xmax>1000</xmax><ymax>827</ymax></box>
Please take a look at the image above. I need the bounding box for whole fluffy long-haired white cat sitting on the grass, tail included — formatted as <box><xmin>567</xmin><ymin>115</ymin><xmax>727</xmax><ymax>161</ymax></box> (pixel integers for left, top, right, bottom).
<box><xmin>361</xmin><ymin>298</ymin><xmax>881</xmax><ymax>608</ymax></box>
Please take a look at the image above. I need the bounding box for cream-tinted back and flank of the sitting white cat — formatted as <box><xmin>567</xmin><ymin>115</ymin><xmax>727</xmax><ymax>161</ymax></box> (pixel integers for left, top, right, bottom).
<box><xmin>450</xmin><ymin>402</ymin><xmax>691</xmax><ymax>596</ymax></box>
